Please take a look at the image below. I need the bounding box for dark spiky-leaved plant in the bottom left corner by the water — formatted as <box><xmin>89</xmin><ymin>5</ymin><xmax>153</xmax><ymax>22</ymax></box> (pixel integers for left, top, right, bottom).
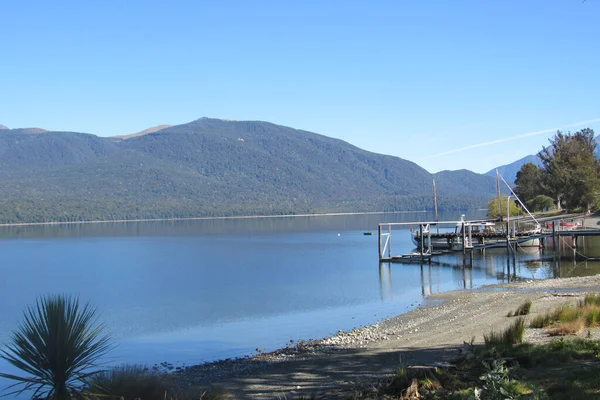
<box><xmin>0</xmin><ymin>295</ymin><xmax>112</xmax><ymax>400</ymax></box>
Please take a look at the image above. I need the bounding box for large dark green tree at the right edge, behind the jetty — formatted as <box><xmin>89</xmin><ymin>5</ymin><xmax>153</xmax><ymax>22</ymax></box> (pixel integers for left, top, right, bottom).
<box><xmin>539</xmin><ymin>128</ymin><xmax>600</xmax><ymax>209</ymax></box>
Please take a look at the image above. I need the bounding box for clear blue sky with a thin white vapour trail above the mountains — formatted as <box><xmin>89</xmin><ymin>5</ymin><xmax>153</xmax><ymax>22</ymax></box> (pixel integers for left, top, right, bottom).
<box><xmin>0</xmin><ymin>0</ymin><xmax>600</xmax><ymax>172</ymax></box>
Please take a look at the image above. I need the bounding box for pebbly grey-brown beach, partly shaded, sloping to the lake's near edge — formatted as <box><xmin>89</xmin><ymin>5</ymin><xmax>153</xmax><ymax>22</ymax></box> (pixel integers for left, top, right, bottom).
<box><xmin>176</xmin><ymin>276</ymin><xmax>600</xmax><ymax>399</ymax></box>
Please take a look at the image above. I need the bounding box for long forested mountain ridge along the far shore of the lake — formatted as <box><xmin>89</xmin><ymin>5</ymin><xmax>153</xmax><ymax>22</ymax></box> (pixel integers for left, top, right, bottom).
<box><xmin>0</xmin><ymin>118</ymin><xmax>495</xmax><ymax>222</ymax></box>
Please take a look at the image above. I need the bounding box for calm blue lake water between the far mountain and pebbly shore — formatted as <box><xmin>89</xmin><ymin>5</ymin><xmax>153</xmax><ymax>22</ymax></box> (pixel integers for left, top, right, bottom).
<box><xmin>0</xmin><ymin>213</ymin><xmax>600</xmax><ymax>376</ymax></box>
